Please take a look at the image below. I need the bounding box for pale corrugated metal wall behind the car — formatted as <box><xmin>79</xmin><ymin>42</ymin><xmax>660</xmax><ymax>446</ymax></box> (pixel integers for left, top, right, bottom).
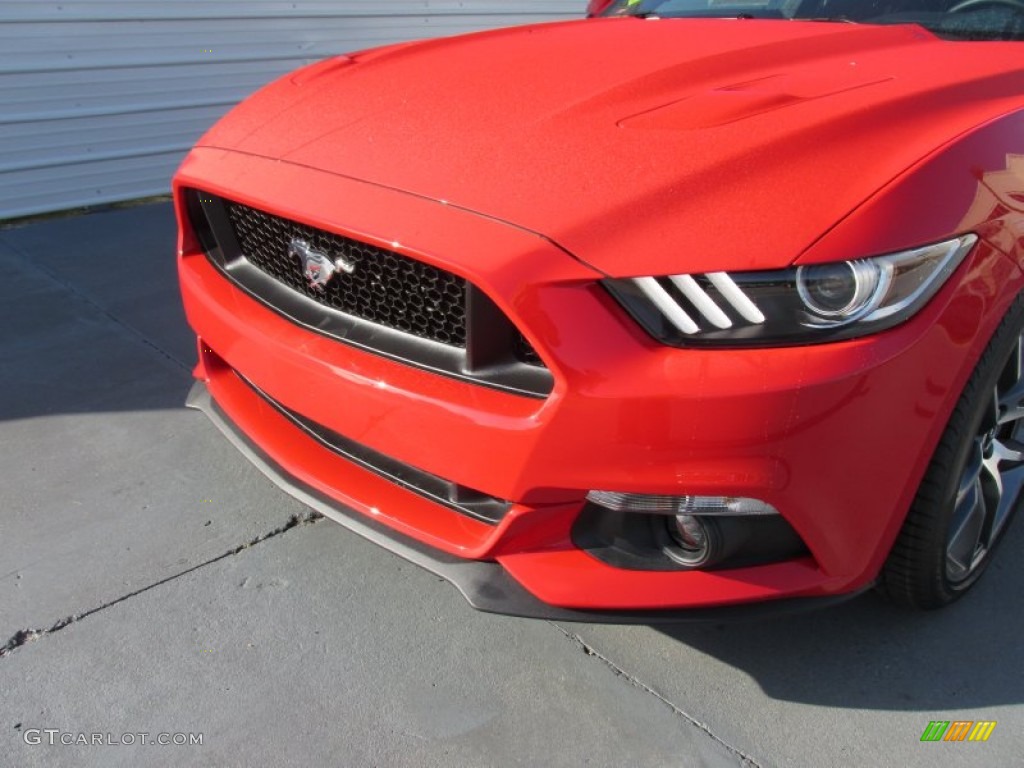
<box><xmin>0</xmin><ymin>0</ymin><xmax>586</xmax><ymax>219</ymax></box>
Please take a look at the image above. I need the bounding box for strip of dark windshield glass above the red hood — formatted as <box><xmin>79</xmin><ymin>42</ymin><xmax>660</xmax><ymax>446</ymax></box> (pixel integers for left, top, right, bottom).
<box><xmin>602</xmin><ymin>0</ymin><xmax>1024</xmax><ymax>40</ymax></box>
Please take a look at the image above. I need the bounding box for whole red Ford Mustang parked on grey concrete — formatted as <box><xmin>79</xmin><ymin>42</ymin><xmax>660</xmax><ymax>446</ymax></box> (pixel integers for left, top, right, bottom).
<box><xmin>174</xmin><ymin>0</ymin><xmax>1024</xmax><ymax>621</ymax></box>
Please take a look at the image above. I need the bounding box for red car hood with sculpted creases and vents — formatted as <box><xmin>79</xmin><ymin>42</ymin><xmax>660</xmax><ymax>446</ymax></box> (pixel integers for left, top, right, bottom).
<box><xmin>201</xmin><ymin>18</ymin><xmax>1024</xmax><ymax>275</ymax></box>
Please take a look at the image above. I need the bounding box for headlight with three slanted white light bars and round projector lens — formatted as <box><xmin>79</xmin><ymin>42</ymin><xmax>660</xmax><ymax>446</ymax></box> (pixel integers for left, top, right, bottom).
<box><xmin>604</xmin><ymin>234</ymin><xmax>978</xmax><ymax>346</ymax></box>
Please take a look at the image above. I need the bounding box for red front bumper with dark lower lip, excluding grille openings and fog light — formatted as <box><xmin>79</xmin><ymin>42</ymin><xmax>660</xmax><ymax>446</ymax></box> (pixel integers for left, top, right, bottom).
<box><xmin>176</xmin><ymin>150</ymin><xmax>1017</xmax><ymax>621</ymax></box>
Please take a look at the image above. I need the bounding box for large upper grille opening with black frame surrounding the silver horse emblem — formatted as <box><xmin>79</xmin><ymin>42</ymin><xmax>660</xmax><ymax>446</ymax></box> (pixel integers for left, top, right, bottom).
<box><xmin>185</xmin><ymin>189</ymin><xmax>554</xmax><ymax>397</ymax></box>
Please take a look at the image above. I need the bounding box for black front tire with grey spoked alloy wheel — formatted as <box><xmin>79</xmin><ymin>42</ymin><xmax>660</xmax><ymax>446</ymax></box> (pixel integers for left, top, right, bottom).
<box><xmin>878</xmin><ymin>294</ymin><xmax>1024</xmax><ymax>608</ymax></box>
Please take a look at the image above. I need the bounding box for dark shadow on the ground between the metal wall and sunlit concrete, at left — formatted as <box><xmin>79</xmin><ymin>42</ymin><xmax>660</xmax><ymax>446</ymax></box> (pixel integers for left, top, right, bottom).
<box><xmin>0</xmin><ymin>203</ymin><xmax>196</xmax><ymax>421</ymax></box>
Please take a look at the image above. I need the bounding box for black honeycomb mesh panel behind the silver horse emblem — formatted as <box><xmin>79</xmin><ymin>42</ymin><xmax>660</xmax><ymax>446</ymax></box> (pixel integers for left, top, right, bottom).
<box><xmin>225</xmin><ymin>201</ymin><xmax>466</xmax><ymax>346</ymax></box>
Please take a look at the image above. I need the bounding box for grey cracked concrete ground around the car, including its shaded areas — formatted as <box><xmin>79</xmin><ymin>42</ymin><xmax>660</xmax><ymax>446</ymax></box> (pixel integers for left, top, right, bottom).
<box><xmin>0</xmin><ymin>204</ymin><xmax>1024</xmax><ymax>768</ymax></box>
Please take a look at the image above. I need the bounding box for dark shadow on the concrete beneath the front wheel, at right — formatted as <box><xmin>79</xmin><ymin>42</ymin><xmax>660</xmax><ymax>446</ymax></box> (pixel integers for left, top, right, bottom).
<box><xmin>655</xmin><ymin>520</ymin><xmax>1024</xmax><ymax>712</ymax></box>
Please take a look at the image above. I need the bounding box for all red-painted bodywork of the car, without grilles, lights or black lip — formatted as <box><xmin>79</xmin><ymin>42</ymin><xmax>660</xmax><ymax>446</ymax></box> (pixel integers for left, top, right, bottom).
<box><xmin>175</xmin><ymin>19</ymin><xmax>1024</xmax><ymax>608</ymax></box>
